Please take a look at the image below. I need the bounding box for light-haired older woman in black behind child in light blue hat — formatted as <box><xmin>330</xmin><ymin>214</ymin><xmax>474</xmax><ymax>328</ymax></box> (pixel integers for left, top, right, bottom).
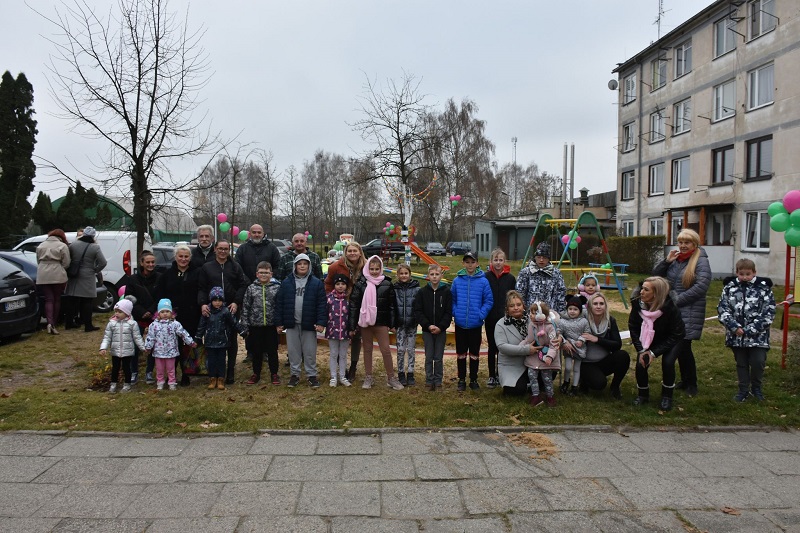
<box><xmin>155</xmin><ymin>244</ymin><xmax>200</xmax><ymax>386</ymax></box>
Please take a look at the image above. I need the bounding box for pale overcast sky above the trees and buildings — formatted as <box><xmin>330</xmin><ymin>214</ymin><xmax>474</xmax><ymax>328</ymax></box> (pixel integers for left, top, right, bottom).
<box><xmin>0</xmin><ymin>0</ymin><xmax>710</xmax><ymax>205</ymax></box>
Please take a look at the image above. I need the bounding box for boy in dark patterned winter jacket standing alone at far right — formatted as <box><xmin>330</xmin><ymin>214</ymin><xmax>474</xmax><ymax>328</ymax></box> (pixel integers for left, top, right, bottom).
<box><xmin>717</xmin><ymin>259</ymin><xmax>775</xmax><ymax>402</ymax></box>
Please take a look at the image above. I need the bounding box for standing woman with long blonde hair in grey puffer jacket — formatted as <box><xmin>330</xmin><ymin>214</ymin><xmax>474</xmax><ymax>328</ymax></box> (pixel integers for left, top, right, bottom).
<box><xmin>653</xmin><ymin>229</ymin><xmax>711</xmax><ymax>396</ymax></box>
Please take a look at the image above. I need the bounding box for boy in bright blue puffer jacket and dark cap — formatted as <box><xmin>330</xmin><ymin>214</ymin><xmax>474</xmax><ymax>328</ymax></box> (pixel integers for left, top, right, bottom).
<box><xmin>450</xmin><ymin>252</ymin><xmax>494</xmax><ymax>391</ymax></box>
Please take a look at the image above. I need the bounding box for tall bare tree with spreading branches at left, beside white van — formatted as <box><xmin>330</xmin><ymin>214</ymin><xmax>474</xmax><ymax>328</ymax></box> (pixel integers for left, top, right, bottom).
<box><xmin>42</xmin><ymin>0</ymin><xmax>214</xmax><ymax>254</ymax></box>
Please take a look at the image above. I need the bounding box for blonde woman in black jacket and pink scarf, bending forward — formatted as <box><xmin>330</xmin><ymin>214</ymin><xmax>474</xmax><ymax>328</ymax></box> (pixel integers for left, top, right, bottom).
<box><xmin>628</xmin><ymin>276</ymin><xmax>685</xmax><ymax>411</ymax></box>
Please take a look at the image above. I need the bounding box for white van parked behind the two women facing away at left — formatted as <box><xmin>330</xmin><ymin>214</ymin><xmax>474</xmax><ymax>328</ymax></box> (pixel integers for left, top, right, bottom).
<box><xmin>14</xmin><ymin>231</ymin><xmax>153</xmax><ymax>311</ymax></box>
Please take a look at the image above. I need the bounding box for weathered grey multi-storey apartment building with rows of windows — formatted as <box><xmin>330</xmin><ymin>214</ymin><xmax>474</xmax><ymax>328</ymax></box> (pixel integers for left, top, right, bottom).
<box><xmin>612</xmin><ymin>0</ymin><xmax>800</xmax><ymax>280</ymax></box>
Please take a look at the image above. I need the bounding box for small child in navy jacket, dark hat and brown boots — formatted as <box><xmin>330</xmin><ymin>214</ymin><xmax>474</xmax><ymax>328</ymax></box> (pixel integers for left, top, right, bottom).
<box><xmin>197</xmin><ymin>287</ymin><xmax>245</xmax><ymax>390</ymax></box>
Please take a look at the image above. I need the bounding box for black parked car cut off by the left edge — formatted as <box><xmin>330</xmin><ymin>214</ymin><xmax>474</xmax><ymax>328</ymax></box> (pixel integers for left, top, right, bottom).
<box><xmin>0</xmin><ymin>258</ymin><xmax>41</xmax><ymax>340</ymax></box>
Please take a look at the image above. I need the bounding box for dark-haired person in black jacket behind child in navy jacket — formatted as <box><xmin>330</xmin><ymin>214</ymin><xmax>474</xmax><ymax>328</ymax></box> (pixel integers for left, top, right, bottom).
<box><xmin>197</xmin><ymin>240</ymin><xmax>250</xmax><ymax>385</ymax></box>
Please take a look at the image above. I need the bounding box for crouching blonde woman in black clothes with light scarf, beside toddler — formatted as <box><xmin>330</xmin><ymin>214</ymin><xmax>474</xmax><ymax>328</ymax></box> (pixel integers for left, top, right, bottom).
<box><xmin>581</xmin><ymin>292</ymin><xmax>631</xmax><ymax>394</ymax></box>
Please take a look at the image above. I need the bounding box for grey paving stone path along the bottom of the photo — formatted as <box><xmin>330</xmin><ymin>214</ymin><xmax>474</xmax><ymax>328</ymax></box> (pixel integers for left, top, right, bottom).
<box><xmin>0</xmin><ymin>427</ymin><xmax>800</xmax><ymax>533</ymax></box>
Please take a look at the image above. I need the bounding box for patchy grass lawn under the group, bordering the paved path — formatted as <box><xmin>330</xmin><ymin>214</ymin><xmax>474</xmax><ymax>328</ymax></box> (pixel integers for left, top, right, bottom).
<box><xmin>0</xmin><ymin>257</ymin><xmax>800</xmax><ymax>434</ymax></box>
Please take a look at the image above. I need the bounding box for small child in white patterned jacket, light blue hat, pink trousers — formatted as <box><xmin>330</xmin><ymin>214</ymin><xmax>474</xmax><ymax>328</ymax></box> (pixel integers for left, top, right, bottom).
<box><xmin>144</xmin><ymin>298</ymin><xmax>197</xmax><ymax>390</ymax></box>
